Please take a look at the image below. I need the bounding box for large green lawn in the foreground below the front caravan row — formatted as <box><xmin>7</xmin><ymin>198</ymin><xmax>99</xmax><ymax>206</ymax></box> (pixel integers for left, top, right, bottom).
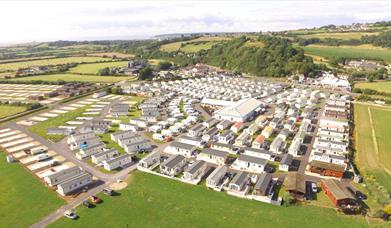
<box><xmin>49</xmin><ymin>172</ymin><xmax>378</xmax><ymax>228</ymax></box>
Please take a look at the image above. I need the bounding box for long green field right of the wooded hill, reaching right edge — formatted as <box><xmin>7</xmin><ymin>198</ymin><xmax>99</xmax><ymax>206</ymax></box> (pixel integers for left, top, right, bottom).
<box><xmin>303</xmin><ymin>45</ymin><xmax>391</xmax><ymax>62</ymax></box>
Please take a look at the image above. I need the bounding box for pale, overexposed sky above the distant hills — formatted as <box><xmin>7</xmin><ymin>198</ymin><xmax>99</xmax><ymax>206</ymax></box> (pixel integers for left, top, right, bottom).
<box><xmin>0</xmin><ymin>0</ymin><xmax>391</xmax><ymax>44</ymax></box>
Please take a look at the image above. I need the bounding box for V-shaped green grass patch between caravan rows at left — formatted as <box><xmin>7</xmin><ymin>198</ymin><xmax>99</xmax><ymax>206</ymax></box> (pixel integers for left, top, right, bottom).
<box><xmin>28</xmin><ymin>105</ymin><xmax>89</xmax><ymax>142</ymax></box>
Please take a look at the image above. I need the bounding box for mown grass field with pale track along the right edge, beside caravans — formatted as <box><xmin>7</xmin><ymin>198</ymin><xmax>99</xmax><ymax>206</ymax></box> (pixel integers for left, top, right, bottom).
<box><xmin>354</xmin><ymin>104</ymin><xmax>391</xmax><ymax>208</ymax></box>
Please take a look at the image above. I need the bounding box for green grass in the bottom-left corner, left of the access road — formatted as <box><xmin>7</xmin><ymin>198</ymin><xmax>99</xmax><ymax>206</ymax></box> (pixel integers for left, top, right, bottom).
<box><xmin>0</xmin><ymin>152</ymin><xmax>64</xmax><ymax>227</ymax></box>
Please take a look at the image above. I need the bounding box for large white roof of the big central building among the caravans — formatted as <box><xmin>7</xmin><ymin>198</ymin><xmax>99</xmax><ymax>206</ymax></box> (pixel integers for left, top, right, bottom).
<box><xmin>216</xmin><ymin>98</ymin><xmax>262</xmax><ymax>118</ymax></box>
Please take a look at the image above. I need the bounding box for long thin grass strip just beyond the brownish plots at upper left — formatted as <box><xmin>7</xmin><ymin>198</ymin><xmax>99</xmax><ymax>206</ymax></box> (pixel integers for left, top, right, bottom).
<box><xmin>9</xmin><ymin>74</ymin><xmax>135</xmax><ymax>83</ymax></box>
